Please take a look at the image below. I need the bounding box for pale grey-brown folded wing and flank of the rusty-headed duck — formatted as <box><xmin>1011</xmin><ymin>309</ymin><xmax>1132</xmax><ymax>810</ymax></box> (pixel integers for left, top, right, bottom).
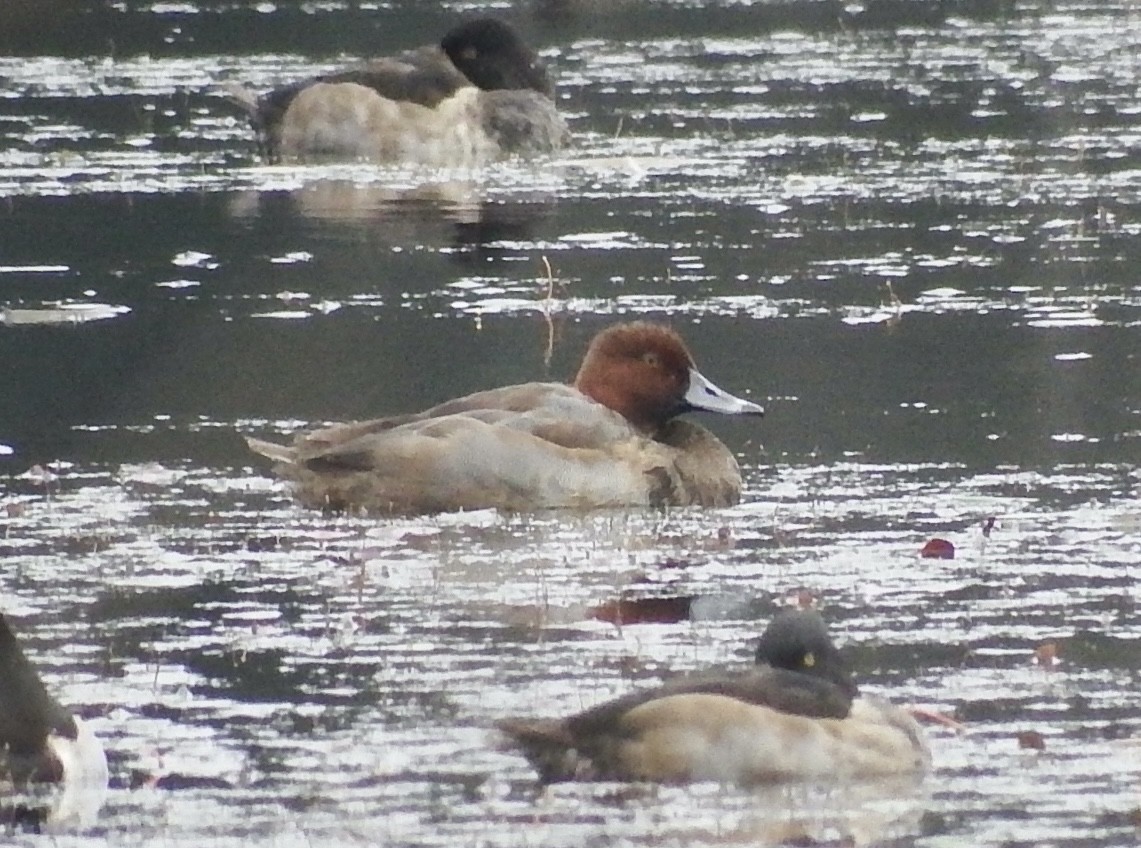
<box><xmin>250</xmin><ymin>383</ymin><xmax>672</xmax><ymax>514</ymax></box>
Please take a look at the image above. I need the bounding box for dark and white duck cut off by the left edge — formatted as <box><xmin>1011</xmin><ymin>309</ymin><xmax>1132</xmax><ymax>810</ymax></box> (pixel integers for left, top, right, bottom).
<box><xmin>0</xmin><ymin>615</ymin><xmax>107</xmax><ymax>830</ymax></box>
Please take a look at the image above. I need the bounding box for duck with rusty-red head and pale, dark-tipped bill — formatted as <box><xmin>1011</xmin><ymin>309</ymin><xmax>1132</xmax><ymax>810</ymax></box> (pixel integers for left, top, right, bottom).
<box><xmin>248</xmin><ymin>322</ymin><xmax>764</xmax><ymax>514</ymax></box>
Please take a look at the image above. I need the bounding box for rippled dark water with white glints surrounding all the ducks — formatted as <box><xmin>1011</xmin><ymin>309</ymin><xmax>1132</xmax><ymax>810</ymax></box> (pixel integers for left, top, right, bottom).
<box><xmin>0</xmin><ymin>0</ymin><xmax>1141</xmax><ymax>846</ymax></box>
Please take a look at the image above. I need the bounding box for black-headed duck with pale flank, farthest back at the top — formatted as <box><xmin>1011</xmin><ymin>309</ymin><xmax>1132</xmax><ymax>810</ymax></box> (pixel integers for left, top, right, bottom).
<box><xmin>229</xmin><ymin>17</ymin><xmax>567</xmax><ymax>168</ymax></box>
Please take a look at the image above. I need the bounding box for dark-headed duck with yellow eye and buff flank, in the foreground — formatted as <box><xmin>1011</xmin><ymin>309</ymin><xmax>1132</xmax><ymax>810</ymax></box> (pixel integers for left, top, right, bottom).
<box><xmin>497</xmin><ymin>609</ymin><xmax>929</xmax><ymax>784</ymax></box>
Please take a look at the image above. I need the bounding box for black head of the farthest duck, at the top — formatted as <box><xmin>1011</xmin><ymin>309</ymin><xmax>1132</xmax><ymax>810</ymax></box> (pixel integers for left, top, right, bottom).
<box><xmin>439</xmin><ymin>17</ymin><xmax>555</xmax><ymax>97</ymax></box>
